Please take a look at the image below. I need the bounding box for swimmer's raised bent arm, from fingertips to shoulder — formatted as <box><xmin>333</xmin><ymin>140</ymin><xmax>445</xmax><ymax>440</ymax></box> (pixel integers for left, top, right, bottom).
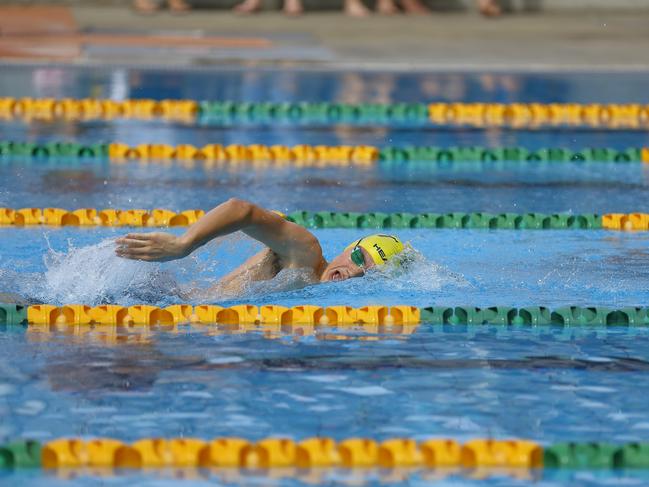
<box><xmin>115</xmin><ymin>198</ymin><xmax>325</xmax><ymax>270</ymax></box>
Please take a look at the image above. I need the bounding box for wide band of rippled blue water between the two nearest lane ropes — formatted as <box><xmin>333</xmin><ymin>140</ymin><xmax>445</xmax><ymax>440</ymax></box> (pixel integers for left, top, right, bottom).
<box><xmin>0</xmin><ymin>325</ymin><xmax>649</xmax><ymax>443</ymax></box>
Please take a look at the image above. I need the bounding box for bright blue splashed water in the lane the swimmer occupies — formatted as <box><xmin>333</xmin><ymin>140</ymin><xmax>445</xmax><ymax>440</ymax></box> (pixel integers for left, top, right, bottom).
<box><xmin>0</xmin><ymin>228</ymin><xmax>649</xmax><ymax>307</ymax></box>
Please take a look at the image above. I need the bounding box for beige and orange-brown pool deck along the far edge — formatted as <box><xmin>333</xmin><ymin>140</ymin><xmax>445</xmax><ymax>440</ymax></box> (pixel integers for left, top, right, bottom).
<box><xmin>0</xmin><ymin>6</ymin><xmax>649</xmax><ymax>71</ymax></box>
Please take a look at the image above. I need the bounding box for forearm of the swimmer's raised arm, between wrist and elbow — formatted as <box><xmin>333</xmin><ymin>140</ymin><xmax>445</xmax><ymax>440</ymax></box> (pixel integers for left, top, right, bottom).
<box><xmin>179</xmin><ymin>198</ymin><xmax>255</xmax><ymax>254</ymax></box>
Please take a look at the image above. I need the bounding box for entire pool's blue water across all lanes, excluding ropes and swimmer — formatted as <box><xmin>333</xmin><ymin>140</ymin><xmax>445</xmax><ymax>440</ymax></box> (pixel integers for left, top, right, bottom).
<box><xmin>0</xmin><ymin>67</ymin><xmax>649</xmax><ymax>485</ymax></box>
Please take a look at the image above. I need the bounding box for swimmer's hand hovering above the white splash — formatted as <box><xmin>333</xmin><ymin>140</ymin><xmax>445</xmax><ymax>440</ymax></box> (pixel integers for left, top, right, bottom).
<box><xmin>115</xmin><ymin>232</ymin><xmax>190</xmax><ymax>262</ymax></box>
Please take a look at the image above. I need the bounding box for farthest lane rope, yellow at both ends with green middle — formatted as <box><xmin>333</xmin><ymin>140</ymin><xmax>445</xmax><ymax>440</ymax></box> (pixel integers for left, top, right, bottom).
<box><xmin>0</xmin><ymin>97</ymin><xmax>649</xmax><ymax>130</ymax></box>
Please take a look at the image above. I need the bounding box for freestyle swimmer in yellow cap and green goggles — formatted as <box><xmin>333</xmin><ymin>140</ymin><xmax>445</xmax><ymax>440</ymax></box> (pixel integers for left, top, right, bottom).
<box><xmin>115</xmin><ymin>198</ymin><xmax>404</xmax><ymax>292</ymax></box>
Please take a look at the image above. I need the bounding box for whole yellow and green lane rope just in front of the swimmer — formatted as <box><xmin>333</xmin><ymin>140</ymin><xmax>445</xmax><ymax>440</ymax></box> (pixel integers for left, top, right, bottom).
<box><xmin>0</xmin><ymin>304</ymin><xmax>649</xmax><ymax>329</ymax></box>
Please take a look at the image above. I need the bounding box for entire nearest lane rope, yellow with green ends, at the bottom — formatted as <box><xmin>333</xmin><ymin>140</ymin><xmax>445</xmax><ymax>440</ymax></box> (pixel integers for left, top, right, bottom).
<box><xmin>0</xmin><ymin>437</ymin><xmax>649</xmax><ymax>476</ymax></box>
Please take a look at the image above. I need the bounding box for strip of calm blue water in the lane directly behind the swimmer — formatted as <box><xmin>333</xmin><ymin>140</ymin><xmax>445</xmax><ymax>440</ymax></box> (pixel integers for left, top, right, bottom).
<box><xmin>0</xmin><ymin>161</ymin><xmax>649</xmax><ymax>213</ymax></box>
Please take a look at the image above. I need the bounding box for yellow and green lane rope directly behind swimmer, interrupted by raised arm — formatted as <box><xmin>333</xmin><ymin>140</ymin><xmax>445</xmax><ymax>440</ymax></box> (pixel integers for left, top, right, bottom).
<box><xmin>0</xmin><ymin>208</ymin><xmax>649</xmax><ymax>231</ymax></box>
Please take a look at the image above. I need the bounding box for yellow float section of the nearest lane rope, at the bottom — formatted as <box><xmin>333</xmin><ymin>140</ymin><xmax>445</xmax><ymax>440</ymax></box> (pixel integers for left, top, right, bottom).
<box><xmin>36</xmin><ymin>437</ymin><xmax>543</xmax><ymax>469</ymax></box>
